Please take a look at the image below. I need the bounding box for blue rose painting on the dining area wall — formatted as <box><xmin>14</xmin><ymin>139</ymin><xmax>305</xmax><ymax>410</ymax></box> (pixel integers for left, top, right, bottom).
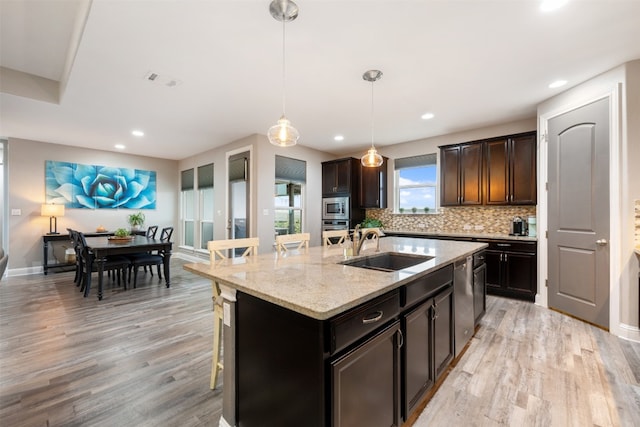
<box><xmin>45</xmin><ymin>160</ymin><xmax>156</xmax><ymax>209</ymax></box>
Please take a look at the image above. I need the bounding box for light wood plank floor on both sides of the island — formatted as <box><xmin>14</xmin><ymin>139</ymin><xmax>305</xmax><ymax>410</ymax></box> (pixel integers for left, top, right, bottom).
<box><xmin>0</xmin><ymin>257</ymin><xmax>640</xmax><ymax>427</ymax></box>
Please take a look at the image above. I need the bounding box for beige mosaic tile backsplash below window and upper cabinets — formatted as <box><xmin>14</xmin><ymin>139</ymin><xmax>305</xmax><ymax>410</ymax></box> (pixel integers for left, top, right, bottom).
<box><xmin>367</xmin><ymin>203</ymin><xmax>536</xmax><ymax>234</ymax></box>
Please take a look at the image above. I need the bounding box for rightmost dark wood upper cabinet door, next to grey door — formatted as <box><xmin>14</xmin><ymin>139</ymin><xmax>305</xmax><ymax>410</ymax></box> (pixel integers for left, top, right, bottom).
<box><xmin>509</xmin><ymin>133</ymin><xmax>537</xmax><ymax>205</ymax></box>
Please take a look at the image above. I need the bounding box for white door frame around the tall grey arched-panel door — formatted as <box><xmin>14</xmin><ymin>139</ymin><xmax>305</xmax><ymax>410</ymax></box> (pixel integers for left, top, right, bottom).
<box><xmin>536</xmin><ymin>83</ymin><xmax>624</xmax><ymax>340</ymax></box>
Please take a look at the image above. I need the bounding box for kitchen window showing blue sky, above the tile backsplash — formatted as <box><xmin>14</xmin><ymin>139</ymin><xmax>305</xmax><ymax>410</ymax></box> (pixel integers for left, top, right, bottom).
<box><xmin>394</xmin><ymin>154</ymin><xmax>437</xmax><ymax>213</ymax></box>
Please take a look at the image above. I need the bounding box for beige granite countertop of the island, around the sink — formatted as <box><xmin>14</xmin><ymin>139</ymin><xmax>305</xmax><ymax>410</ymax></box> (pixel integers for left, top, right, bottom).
<box><xmin>184</xmin><ymin>237</ymin><xmax>487</xmax><ymax>320</ymax></box>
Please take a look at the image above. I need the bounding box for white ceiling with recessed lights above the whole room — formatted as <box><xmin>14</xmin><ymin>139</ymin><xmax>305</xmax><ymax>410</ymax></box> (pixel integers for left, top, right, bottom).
<box><xmin>0</xmin><ymin>0</ymin><xmax>640</xmax><ymax>159</ymax></box>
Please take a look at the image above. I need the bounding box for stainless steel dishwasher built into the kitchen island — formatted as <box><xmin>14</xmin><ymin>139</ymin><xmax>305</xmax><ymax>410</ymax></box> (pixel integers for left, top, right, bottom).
<box><xmin>453</xmin><ymin>256</ymin><xmax>474</xmax><ymax>357</ymax></box>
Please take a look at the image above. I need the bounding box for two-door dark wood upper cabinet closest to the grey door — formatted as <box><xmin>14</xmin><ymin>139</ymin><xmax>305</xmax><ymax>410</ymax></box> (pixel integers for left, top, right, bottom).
<box><xmin>484</xmin><ymin>132</ymin><xmax>537</xmax><ymax>205</ymax></box>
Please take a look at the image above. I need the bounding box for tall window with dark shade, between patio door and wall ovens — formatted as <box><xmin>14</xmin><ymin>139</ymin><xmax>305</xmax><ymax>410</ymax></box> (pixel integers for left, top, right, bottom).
<box><xmin>274</xmin><ymin>156</ymin><xmax>307</xmax><ymax>235</ymax></box>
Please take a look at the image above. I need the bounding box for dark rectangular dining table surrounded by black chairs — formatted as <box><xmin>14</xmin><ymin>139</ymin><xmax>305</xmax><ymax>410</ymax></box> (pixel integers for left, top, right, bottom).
<box><xmin>85</xmin><ymin>235</ymin><xmax>172</xmax><ymax>300</ymax></box>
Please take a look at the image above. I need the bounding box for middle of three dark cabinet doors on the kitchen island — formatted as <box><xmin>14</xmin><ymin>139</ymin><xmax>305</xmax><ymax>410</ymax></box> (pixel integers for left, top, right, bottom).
<box><xmin>403</xmin><ymin>298</ymin><xmax>434</xmax><ymax>419</ymax></box>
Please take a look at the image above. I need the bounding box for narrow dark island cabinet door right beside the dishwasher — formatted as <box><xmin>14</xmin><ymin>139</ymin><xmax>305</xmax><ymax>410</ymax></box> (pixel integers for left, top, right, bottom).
<box><xmin>432</xmin><ymin>287</ymin><xmax>454</xmax><ymax>380</ymax></box>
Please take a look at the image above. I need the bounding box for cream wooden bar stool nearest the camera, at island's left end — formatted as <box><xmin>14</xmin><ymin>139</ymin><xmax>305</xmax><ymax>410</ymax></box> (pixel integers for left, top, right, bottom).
<box><xmin>207</xmin><ymin>237</ymin><xmax>260</xmax><ymax>390</ymax></box>
